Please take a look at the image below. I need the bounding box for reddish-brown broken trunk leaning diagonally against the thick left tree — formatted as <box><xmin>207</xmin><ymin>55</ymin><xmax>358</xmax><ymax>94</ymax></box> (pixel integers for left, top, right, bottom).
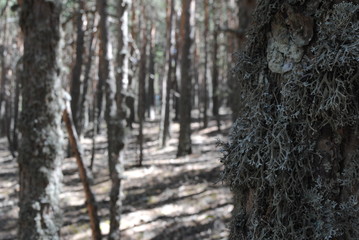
<box><xmin>62</xmin><ymin>95</ymin><xmax>102</xmax><ymax>240</ymax></box>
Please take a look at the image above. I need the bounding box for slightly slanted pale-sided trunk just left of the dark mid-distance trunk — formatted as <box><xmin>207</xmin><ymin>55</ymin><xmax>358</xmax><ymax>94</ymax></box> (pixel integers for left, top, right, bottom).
<box><xmin>160</xmin><ymin>0</ymin><xmax>174</xmax><ymax>147</ymax></box>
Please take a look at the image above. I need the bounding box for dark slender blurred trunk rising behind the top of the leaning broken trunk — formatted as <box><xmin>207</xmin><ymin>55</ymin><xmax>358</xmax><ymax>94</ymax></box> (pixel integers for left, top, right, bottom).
<box><xmin>70</xmin><ymin>0</ymin><xmax>85</xmax><ymax>135</ymax></box>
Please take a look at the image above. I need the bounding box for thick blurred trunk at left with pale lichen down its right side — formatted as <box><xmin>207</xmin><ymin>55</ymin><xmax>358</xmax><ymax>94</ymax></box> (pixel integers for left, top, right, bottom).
<box><xmin>18</xmin><ymin>0</ymin><xmax>63</xmax><ymax>240</ymax></box>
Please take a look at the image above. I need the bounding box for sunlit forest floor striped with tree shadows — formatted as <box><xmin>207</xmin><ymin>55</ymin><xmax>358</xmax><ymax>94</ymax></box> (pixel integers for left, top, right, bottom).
<box><xmin>0</xmin><ymin>113</ymin><xmax>233</xmax><ymax>240</ymax></box>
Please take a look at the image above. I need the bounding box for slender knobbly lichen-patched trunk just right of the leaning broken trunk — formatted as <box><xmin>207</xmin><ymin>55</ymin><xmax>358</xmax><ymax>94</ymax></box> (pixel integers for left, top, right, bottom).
<box><xmin>108</xmin><ymin>0</ymin><xmax>131</xmax><ymax>240</ymax></box>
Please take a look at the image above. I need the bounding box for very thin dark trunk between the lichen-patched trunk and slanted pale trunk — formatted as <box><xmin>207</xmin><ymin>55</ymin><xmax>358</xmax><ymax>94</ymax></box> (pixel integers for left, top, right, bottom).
<box><xmin>138</xmin><ymin>5</ymin><xmax>147</xmax><ymax>166</ymax></box>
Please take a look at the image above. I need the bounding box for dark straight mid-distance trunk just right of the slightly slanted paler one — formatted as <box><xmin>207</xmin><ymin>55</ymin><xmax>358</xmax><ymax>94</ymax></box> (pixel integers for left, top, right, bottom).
<box><xmin>177</xmin><ymin>0</ymin><xmax>195</xmax><ymax>157</ymax></box>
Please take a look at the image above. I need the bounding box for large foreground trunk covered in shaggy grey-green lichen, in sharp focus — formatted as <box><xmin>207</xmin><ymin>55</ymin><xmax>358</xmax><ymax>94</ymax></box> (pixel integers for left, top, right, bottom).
<box><xmin>222</xmin><ymin>0</ymin><xmax>359</xmax><ymax>240</ymax></box>
